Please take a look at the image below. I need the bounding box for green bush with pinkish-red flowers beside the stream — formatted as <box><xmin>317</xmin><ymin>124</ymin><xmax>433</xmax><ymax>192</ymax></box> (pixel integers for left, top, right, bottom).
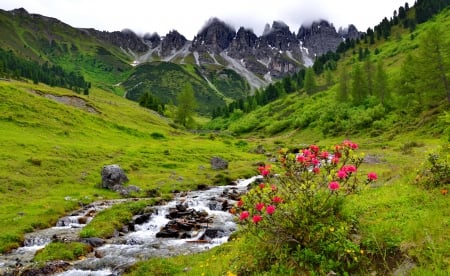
<box><xmin>235</xmin><ymin>141</ymin><xmax>377</xmax><ymax>274</ymax></box>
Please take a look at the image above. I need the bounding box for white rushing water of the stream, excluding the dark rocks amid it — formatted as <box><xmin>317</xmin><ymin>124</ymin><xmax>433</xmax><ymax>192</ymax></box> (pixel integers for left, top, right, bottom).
<box><xmin>0</xmin><ymin>177</ymin><xmax>257</xmax><ymax>276</ymax></box>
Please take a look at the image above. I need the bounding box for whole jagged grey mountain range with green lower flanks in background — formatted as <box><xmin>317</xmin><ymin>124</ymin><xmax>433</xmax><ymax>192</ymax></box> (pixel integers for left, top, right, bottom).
<box><xmin>0</xmin><ymin>8</ymin><xmax>359</xmax><ymax>114</ymax></box>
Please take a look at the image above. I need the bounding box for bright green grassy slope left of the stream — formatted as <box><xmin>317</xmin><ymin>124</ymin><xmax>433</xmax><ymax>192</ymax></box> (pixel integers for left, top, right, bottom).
<box><xmin>0</xmin><ymin>81</ymin><xmax>260</xmax><ymax>252</ymax></box>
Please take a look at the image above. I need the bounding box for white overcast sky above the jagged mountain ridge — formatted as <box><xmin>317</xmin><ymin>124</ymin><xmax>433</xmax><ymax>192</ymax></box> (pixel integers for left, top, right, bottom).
<box><xmin>0</xmin><ymin>0</ymin><xmax>414</xmax><ymax>40</ymax></box>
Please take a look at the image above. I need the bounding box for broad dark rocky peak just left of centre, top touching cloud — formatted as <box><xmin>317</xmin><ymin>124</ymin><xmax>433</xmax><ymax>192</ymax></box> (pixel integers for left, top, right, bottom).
<box><xmin>192</xmin><ymin>18</ymin><xmax>236</xmax><ymax>53</ymax></box>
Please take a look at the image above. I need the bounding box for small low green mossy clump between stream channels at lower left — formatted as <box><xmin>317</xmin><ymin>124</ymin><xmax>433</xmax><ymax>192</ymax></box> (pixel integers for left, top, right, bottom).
<box><xmin>34</xmin><ymin>242</ymin><xmax>92</xmax><ymax>263</ymax></box>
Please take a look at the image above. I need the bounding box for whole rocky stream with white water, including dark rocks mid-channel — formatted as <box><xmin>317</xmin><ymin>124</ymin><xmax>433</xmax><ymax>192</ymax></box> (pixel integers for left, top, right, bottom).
<box><xmin>0</xmin><ymin>176</ymin><xmax>259</xmax><ymax>276</ymax></box>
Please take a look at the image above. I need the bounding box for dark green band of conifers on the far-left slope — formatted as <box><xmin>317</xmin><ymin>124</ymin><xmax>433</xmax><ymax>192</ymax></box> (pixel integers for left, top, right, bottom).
<box><xmin>0</xmin><ymin>48</ymin><xmax>91</xmax><ymax>95</ymax></box>
